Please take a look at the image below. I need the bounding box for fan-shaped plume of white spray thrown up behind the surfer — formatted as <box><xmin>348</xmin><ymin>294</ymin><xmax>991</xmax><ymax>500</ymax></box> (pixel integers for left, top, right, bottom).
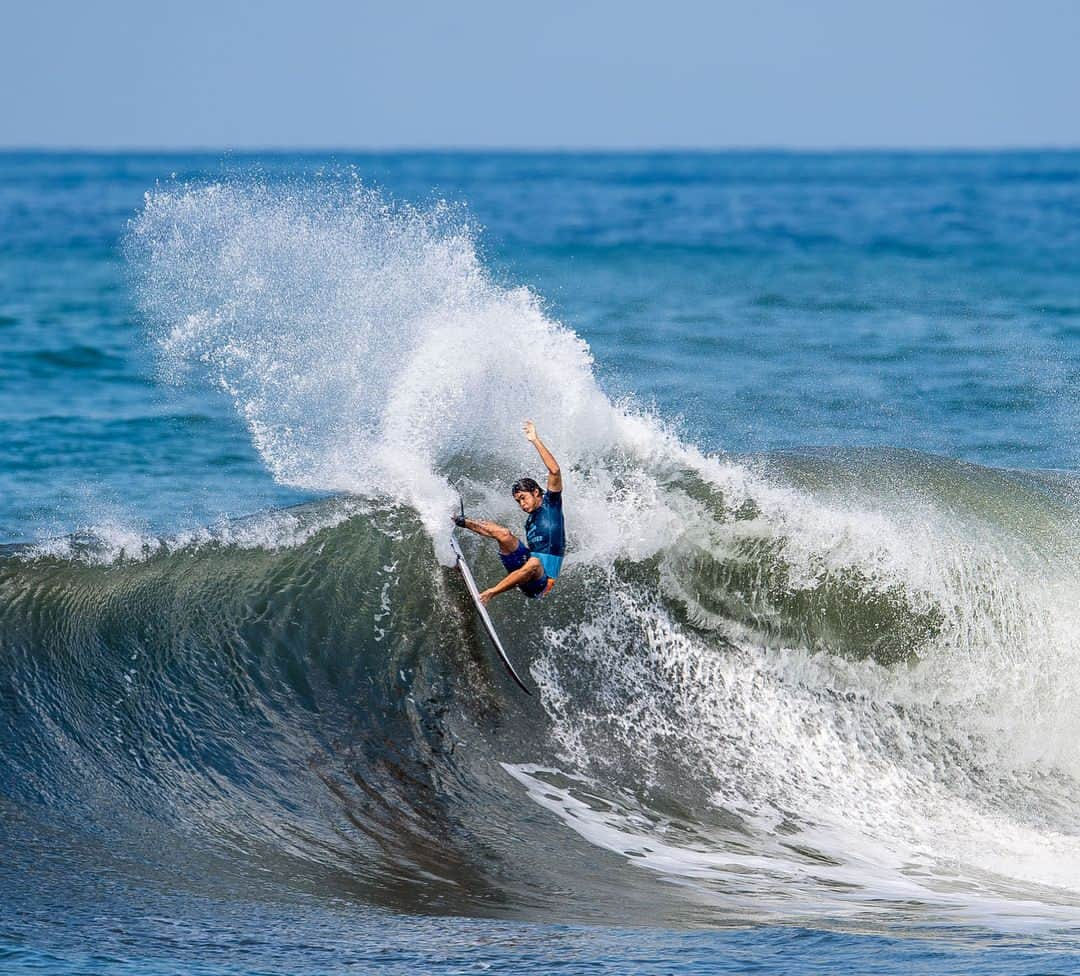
<box><xmin>129</xmin><ymin>181</ymin><xmax>612</xmax><ymax>533</ymax></box>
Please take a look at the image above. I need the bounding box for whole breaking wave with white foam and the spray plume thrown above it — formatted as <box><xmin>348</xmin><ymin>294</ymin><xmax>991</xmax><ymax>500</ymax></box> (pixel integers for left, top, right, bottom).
<box><xmin>0</xmin><ymin>174</ymin><xmax>1080</xmax><ymax>925</ymax></box>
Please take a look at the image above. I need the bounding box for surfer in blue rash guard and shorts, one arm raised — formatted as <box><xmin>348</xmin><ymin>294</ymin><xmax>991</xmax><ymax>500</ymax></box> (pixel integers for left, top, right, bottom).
<box><xmin>454</xmin><ymin>420</ymin><xmax>566</xmax><ymax>606</ymax></box>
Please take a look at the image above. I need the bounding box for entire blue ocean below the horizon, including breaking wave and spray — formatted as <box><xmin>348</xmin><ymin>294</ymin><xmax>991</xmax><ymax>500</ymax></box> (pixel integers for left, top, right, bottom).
<box><xmin>0</xmin><ymin>152</ymin><xmax>1080</xmax><ymax>976</ymax></box>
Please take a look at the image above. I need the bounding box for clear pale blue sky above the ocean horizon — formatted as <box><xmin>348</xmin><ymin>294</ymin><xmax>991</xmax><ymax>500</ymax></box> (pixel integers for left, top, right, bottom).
<box><xmin>0</xmin><ymin>0</ymin><xmax>1080</xmax><ymax>148</ymax></box>
